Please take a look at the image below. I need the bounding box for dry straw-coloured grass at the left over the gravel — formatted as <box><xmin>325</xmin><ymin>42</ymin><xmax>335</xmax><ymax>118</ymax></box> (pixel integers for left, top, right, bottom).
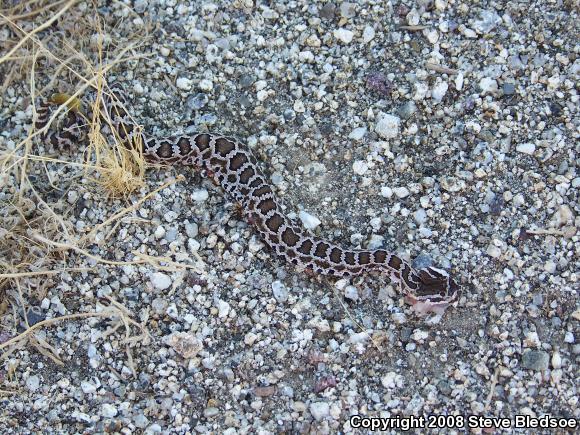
<box><xmin>0</xmin><ymin>0</ymin><xmax>190</xmax><ymax>382</ymax></box>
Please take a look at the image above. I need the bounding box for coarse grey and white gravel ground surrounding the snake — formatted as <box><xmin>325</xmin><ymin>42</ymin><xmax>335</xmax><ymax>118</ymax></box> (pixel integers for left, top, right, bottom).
<box><xmin>0</xmin><ymin>0</ymin><xmax>580</xmax><ymax>434</ymax></box>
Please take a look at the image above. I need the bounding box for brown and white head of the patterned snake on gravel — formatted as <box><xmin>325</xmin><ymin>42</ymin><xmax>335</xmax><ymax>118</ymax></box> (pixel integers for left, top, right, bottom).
<box><xmin>405</xmin><ymin>267</ymin><xmax>461</xmax><ymax>315</ymax></box>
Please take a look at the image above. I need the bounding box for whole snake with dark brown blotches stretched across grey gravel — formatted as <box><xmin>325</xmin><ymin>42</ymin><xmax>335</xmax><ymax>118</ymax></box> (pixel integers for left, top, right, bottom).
<box><xmin>35</xmin><ymin>84</ymin><xmax>460</xmax><ymax>315</ymax></box>
